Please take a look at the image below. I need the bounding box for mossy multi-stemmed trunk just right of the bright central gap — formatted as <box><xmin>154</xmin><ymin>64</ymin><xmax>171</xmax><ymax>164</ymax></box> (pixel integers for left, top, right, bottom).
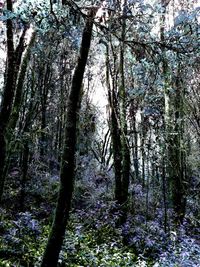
<box><xmin>103</xmin><ymin>0</ymin><xmax>130</xmax><ymax>207</ymax></box>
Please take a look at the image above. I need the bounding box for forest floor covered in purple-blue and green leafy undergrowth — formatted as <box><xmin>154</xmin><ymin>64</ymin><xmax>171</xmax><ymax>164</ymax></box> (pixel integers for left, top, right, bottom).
<box><xmin>0</xmin><ymin>171</ymin><xmax>200</xmax><ymax>267</ymax></box>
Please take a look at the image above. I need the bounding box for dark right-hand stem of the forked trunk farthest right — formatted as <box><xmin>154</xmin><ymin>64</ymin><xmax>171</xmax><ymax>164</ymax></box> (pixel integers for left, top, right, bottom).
<box><xmin>170</xmin><ymin>65</ymin><xmax>186</xmax><ymax>224</ymax></box>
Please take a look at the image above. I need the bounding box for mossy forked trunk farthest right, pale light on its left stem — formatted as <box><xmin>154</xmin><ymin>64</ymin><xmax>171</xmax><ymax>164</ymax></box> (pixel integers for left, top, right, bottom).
<box><xmin>161</xmin><ymin>1</ymin><xmax>186</xmax><ymax>224</ymax></box>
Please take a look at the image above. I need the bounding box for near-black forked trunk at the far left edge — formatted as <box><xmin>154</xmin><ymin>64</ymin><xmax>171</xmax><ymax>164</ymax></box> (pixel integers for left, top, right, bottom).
<box><xmin>0</xmin><ymin>0</ymin><xmax>27</xmax><ymax>201</ymax></box>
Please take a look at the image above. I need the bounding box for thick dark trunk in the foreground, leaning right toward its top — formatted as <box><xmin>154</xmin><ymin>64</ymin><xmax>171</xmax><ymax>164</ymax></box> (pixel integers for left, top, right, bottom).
<box><xmin>41</xmin><ymin>9</ymin><xmax>95</xmax><ymax>267</ymax></box>
